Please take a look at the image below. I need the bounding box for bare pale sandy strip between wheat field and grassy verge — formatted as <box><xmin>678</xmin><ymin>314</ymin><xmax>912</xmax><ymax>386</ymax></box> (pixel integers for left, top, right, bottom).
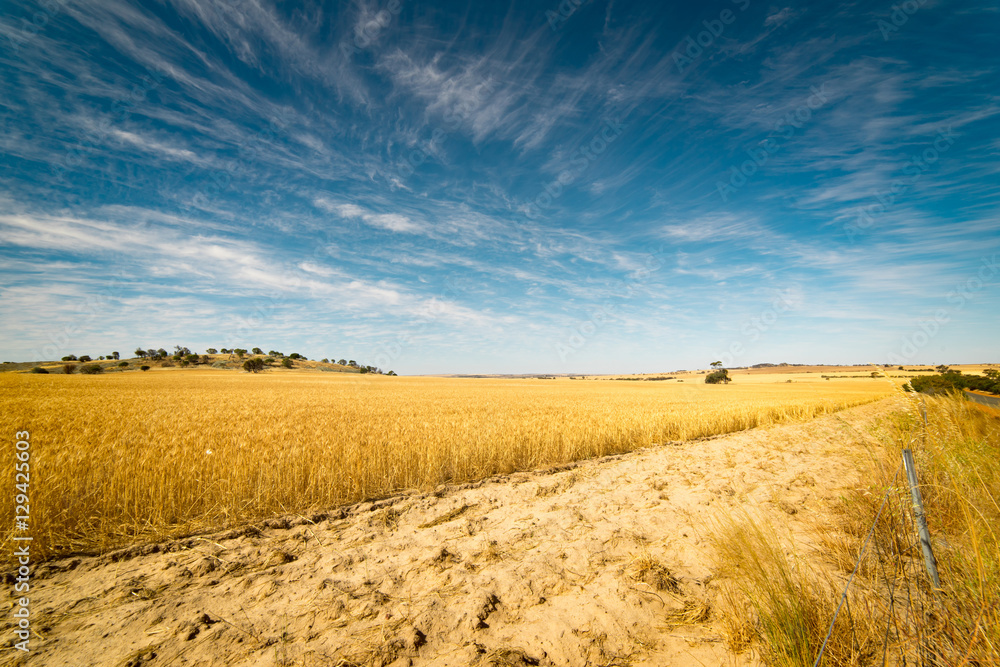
<box><xmin>0</xmin><ymin>399</ymin><xmax>893</xmax><ymax>667</ymax></box>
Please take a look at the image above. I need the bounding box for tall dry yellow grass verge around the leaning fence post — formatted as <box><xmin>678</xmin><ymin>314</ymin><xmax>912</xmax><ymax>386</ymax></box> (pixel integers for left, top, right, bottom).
<box><xmin>715</xmin><ymin>396</ymin><xmax>1000</xmax><ymax>665</ymax></box>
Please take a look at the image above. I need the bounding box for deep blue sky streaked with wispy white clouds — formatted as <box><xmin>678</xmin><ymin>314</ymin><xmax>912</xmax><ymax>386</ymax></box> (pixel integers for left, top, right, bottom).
<box><xmin>0</xmin><ymin>0</ymin><xmax>1000</xmax><ymax>373</ymax></box>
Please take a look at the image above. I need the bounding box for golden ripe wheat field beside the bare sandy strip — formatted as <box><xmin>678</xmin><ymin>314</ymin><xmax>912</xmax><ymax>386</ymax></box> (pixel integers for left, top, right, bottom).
<box><xmin>0</xmin><ymin>371</ymin><xmax>892</xmax><ymax>556</ymax></box>
